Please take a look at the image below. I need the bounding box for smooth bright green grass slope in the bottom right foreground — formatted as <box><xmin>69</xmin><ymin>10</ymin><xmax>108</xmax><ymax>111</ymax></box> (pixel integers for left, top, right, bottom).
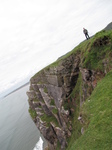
<box><xmin>70</xmin><ymin>71</ymin><xmax>112</xmax><ymax>150</ymax></box>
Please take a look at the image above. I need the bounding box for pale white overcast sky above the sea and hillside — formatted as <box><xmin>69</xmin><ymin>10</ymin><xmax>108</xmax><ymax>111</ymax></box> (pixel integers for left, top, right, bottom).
<box><xmin>0</xmin><ymin>0</ymin><xmax>112</xmax><ymax>97</ymax></box>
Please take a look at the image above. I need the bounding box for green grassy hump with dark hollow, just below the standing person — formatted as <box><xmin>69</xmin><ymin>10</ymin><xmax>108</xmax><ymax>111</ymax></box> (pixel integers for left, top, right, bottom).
<box><xmin>83</xmin><ymin>31</ymin><xmax>112</xmax><ymax>71</ymax></box>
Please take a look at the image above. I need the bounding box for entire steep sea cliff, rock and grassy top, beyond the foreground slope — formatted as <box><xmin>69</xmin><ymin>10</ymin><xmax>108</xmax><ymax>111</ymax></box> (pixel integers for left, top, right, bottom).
<box><xmin>27</xmin><ymin>27</ymin><xmax>112</xmax><ymax>150</ymax></box>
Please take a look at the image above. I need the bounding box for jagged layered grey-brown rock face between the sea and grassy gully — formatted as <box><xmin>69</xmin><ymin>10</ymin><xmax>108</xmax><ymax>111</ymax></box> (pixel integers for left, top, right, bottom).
<box><xmin>27</xmin><ymin>55</ymin><xmax>80</xmax><ymax>149</ymax></box>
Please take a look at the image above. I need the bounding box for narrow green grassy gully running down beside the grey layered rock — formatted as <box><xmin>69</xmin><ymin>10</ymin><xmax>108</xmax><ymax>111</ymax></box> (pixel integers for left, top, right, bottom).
<box><xmin>67</xmin><ymin>75</ymin><xmax>82</xmax><ymax>150</ymax></box>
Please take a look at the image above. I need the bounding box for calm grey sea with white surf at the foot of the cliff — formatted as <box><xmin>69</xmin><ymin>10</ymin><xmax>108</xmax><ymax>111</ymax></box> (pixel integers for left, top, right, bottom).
<box><xmin>0</xmin><ymin>85</ymin><xmax>46</xmax><ymax>150</ymax></box>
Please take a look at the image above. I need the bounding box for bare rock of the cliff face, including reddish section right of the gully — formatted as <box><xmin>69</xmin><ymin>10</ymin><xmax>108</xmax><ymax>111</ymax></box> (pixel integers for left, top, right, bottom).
<box><xmin>27</xmin><ymin>28</ymin><xmax>110</xmax><ymax>150</ymax></box>
